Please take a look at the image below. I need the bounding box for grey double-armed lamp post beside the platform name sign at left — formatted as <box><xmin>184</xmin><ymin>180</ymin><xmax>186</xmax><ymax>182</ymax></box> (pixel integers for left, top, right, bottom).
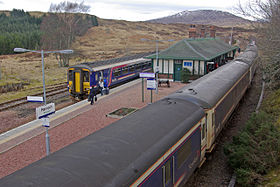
<box><xmin>14</xmin><ymin>48</ymin><xmax>73</xmax><ymax>156</ymax></box>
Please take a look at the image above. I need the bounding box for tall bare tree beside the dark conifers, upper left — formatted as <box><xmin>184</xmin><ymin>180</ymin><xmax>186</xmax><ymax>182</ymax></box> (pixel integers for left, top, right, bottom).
<box><xmin>41</xmin><ymin>1</ymin><xmax>92</xmax><ymax>66</ymax></box>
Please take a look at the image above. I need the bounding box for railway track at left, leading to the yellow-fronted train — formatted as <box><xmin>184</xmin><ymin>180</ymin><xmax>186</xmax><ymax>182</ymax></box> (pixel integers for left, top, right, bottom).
<box><xmin>0</xmin><ymin>83</ymin><xmax>68</xmax><ymax>112</ymax></box>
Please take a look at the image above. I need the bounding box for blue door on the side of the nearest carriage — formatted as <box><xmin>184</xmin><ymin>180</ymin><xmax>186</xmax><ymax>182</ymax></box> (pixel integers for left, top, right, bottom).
<box><xmin>162</xmin><ymin>156</ymin><xmax>175</xmax><ymax>187</ymax></box>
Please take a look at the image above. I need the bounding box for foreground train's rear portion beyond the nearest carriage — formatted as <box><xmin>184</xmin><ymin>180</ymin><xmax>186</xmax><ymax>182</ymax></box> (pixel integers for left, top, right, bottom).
<box><xmin>168</xmin><ymin>46</ymin><xmax>257</xmax><ymax>152</ymax></box>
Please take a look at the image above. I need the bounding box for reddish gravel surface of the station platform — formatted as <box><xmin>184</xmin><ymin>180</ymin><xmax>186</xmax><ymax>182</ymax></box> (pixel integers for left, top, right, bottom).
<box><xmin>0</xmin><ymin>82</ymin><xmax>185</xmax><ymax>178</ymax></box>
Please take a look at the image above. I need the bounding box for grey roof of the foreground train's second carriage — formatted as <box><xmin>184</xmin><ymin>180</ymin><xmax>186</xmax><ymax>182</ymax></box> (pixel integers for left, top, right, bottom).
<box><xmin>168</xmin><ymin>61</ymin><xmax>248</xmax><ymax>109</ymax></box>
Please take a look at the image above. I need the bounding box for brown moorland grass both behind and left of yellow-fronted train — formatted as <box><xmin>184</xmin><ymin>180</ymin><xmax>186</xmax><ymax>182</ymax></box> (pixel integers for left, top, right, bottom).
<box><xmin>0</xmin><ymin>19</ymin><xmax>254</xmax><ymax>103</ymax></box>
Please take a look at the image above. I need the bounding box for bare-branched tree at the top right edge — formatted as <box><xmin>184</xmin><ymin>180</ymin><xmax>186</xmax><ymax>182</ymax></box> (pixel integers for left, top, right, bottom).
<box><xmin>238</xmin><ymin>0</ymin><xmax>280</xmax><ymax>88</ymax></box>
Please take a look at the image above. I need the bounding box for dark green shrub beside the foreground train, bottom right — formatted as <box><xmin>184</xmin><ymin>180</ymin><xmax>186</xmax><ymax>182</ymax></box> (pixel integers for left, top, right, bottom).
<box><xmin>224</xmin><ymin>112</ymin><xmax>280</xmax><ymax>186</ymax></box>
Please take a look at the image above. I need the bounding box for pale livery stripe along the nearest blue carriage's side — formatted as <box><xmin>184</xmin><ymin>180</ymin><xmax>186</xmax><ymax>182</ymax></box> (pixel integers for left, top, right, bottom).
<box><xmin>130</xmin><ymin>118</ymin><xmax>203</xmax><ymax>187</ymax></box>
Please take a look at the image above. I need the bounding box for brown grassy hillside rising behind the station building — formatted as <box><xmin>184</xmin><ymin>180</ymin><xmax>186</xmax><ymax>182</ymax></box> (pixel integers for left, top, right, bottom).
<box><xmin>73</xmin><ymin>19</ymin><xmax>254</xmax><ymax>61</ymax></box>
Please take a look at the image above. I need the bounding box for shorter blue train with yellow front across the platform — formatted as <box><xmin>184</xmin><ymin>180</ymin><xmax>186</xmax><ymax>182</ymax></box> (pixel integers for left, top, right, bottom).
<box><xmin>67</xmin><ymin>52</ymin><xmax>153</xmax><ymax>100</ymax></box>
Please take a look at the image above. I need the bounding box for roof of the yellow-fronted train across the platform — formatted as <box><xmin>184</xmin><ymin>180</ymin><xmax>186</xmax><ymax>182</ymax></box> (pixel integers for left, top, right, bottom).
<box><xmin>69</xmin><ymin>52</ymin><xmax>154</xmax><ymax>71</ymax></box>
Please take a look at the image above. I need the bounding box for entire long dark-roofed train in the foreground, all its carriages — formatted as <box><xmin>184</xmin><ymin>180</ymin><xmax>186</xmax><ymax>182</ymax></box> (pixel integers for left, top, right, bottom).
<box><xmin>0</xmin><ymin>45</ymin><xmax>257</xmax><ymax>187</ymax></box>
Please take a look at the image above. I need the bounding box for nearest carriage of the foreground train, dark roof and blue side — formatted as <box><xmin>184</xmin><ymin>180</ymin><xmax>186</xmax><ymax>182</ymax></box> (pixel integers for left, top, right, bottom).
<box><xmin>0</xmin><ymin>99</ymin><xmax>204</xmax><ymax>187</ymax></box>
